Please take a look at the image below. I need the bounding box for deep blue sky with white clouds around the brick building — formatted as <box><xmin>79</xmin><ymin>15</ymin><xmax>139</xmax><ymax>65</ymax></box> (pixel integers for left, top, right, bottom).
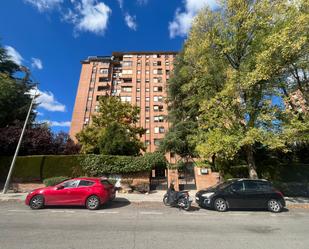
<box><xmin>0</xmin><ymin>0</ymin><xmax>215</xmax><ymax>131</ymax></box>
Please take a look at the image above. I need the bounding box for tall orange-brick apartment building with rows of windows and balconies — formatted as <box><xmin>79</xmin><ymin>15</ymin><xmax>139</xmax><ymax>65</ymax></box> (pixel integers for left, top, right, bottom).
<box><xmin>70</xmin><ymin>52</ymin><xmax>177</xmax><ymax>160</ymax></box>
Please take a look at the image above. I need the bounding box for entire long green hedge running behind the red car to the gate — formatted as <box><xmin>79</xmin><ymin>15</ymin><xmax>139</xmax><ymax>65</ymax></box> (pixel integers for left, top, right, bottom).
<box><xmin>0</xmin><ymin>153</ymin><xmax>166</xmax><ymax>182</ymax></box>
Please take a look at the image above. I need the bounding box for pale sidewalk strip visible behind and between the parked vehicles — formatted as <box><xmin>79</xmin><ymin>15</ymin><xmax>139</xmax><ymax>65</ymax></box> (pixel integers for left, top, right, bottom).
<box><xmin>0</xmin><ymin>190</ymin><xmax>309</xmax><ymax>209</ymax></box>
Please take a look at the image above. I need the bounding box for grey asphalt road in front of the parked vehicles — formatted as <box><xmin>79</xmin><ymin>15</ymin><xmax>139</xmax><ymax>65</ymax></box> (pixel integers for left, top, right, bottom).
<box><xmin>0</xmin><ymin>202</ymin><xmax>309</xmax><ymax>249</ymax></box>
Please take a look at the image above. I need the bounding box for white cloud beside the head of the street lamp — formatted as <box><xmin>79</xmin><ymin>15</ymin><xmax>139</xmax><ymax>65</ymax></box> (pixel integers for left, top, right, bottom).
<box><xmin>30</xmin><ymin>89</ymin><xmax>66</xmax><ymax>112</ymax></box>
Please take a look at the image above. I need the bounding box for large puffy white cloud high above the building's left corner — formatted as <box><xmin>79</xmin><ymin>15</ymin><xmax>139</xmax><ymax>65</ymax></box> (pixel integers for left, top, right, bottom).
<box><xmin>64</xmin><ymin>0</ymin><xmax>112</xmax><ymax>35</ymax></box>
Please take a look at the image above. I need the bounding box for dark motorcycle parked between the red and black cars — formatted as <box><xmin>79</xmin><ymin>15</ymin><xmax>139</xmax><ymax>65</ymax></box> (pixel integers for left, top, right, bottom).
<box><xmin>163</xmin><ymin>191</ymin><xmax>192</xmax><ymax>211</ymax></box>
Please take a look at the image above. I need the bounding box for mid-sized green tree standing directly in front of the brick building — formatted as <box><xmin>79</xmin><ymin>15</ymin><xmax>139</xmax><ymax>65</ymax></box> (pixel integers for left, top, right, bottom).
<box><xmin>76</xmin><ymin>96</ymin><xmax>145</xmax><ymax>155</ymax></box>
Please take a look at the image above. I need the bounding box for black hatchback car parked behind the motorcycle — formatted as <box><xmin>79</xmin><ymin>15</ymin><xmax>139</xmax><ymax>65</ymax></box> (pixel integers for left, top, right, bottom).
<box><xmin>195</xmin><ymin>179</ymin><xmax>285</xmax><ymax>213</ymax></box>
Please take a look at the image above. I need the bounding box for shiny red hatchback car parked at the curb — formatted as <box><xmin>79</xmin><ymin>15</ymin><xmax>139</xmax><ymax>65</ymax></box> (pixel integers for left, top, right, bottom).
<box><xmin>25</xmin><ymin>177</ymin><xmax>115</xmax><ymax>210</ymax></box>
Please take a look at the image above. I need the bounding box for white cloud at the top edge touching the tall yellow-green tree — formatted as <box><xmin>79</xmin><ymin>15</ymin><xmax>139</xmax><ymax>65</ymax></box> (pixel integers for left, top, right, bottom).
<box><xmin>168</xmin><ymin>0</ymin><xmax>217</xmax><ymax>38</ymax></box>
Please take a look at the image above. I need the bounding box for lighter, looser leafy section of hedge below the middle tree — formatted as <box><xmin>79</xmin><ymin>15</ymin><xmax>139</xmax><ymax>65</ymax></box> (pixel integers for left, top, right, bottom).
<box><xmin>80</xmin><ymin>153</ymin><xmax>166</xmax><ymax>176</ymax></box>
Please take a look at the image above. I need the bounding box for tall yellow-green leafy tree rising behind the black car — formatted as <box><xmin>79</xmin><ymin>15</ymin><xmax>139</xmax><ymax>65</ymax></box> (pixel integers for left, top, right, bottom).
<box><xmin>167</xmin><ymin>0</ymin><xmax>309</xmax><ymax>178</ymax></box>
